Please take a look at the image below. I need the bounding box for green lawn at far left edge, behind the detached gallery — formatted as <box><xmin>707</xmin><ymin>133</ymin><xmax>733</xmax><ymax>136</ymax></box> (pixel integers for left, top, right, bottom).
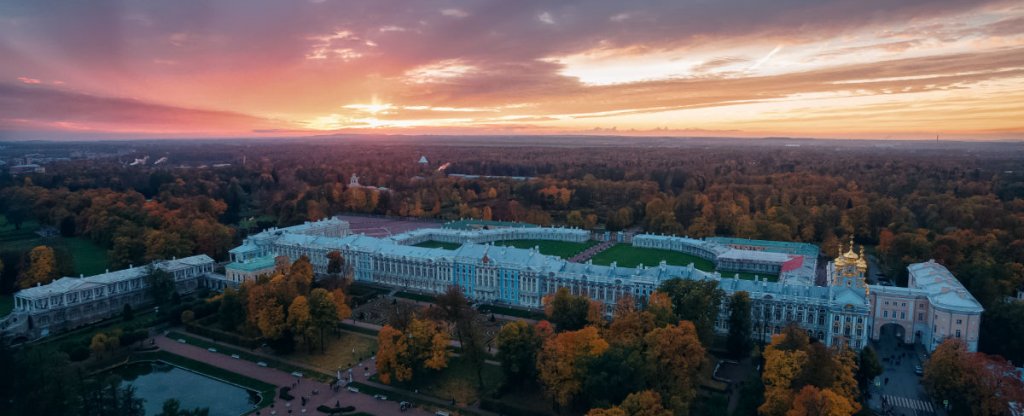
<box><xmin>0</xmin><ymin>217</ymin><xmax>108</xmax><ymax>276</ymax></box>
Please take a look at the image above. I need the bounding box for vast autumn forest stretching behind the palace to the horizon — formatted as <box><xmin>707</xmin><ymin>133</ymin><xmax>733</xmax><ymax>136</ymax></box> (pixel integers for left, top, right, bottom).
<box><xmin>0</xmin><ymin>137</ymin><xmax>1024</xmax><ymax>383</ymax></box>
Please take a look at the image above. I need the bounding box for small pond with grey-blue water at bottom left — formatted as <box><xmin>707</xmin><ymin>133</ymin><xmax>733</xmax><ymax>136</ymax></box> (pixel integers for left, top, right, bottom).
<box><xmin>112</xmin><ymin>362</ymin><xmax>259</xmax><ymax>416</ymax></box>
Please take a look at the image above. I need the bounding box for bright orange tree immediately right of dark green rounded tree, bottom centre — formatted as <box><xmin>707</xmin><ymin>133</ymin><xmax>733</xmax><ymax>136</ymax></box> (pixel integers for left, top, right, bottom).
<box><xmin>537</xmin><ymin>327</ymin><xmax>608</xmax><ymax>407</ymax></box>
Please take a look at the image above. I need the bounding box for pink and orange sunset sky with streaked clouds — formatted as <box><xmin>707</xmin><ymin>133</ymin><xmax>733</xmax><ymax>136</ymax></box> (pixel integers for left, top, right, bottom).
<box><xmin>0</xmin><ymin>0</ymin><xmax>1024</xmax><ymax>140</ymax></box>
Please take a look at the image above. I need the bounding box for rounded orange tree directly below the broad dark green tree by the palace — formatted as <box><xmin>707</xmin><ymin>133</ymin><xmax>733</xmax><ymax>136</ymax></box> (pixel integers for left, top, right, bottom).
<box><xmin>644</xmin><ymin>321</ymin><xmax>705</xmax><ymax>415</ymax></box>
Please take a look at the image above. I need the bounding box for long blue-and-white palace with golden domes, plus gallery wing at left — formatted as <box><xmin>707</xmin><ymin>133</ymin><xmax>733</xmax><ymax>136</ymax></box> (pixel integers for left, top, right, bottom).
<box><xmin>2</xmin><ymin>218</ymin><xmax>983</xmax><ymax>350</ymax></box>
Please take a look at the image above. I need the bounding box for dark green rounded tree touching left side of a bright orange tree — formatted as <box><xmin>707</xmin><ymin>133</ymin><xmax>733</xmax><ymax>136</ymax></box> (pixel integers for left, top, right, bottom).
<box><xmin>498</xmin><ymin>321</ymin><xmax>543</xmax><ymax>386</ymax></box>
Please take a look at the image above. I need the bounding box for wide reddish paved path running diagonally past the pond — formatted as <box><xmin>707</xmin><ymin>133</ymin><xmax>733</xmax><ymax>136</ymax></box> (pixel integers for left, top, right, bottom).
<box><xmin>156</xmin><ymin>335</ymin><xmax>430</xmax><ymax>416</ymax></box>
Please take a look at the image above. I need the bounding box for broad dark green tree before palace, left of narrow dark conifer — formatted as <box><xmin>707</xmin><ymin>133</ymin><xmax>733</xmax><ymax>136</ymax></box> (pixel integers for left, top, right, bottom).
<box><xmin>658</xmin><ymin>278</ymin><xmax>725</xmax><ymax>344</ymax></box>
